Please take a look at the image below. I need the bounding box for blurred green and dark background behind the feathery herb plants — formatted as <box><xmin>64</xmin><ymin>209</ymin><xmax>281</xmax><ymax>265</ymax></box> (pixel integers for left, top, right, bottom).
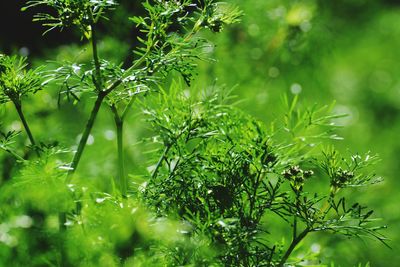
<box><xmin>0</xmin><ymin>0</ymin><xmax>400</xmax><ymax>266</ymax></box>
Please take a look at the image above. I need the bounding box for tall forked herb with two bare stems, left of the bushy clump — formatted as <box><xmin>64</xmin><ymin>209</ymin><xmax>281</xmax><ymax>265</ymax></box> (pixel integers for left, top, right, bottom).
<box><xmin>26</xmin><ymin>0</ymin><xmax>240</xmax><ymax>196</ymax></box>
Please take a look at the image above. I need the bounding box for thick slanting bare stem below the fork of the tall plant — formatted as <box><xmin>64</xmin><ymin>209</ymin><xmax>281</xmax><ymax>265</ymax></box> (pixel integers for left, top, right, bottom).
<box><xmin>66</xmin><ymin>92</ymin><xmax>106</xmax><ymax>183</ymax></box>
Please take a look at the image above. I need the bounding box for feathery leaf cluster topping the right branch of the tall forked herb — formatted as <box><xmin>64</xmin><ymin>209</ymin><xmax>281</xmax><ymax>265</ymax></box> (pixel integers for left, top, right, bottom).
<box><xmin>131</xmin><ymin>0</ymin><xmax>241</xmax><ymax>84</ymax></box>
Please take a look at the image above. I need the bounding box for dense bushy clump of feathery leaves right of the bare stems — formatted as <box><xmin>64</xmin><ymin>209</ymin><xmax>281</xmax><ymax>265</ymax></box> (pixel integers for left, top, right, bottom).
<box><xmin>142</xmin><ymin>90</ymin><xmax>386</xmax><ymax>266</ymax></box>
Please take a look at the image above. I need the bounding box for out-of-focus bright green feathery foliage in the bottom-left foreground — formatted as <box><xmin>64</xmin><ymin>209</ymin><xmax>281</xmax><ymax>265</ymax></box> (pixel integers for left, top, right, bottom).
<box><xmin>0</xmin><ymin>156</ymin><xmax>214</xmax><ymax>266</ymax></box>
